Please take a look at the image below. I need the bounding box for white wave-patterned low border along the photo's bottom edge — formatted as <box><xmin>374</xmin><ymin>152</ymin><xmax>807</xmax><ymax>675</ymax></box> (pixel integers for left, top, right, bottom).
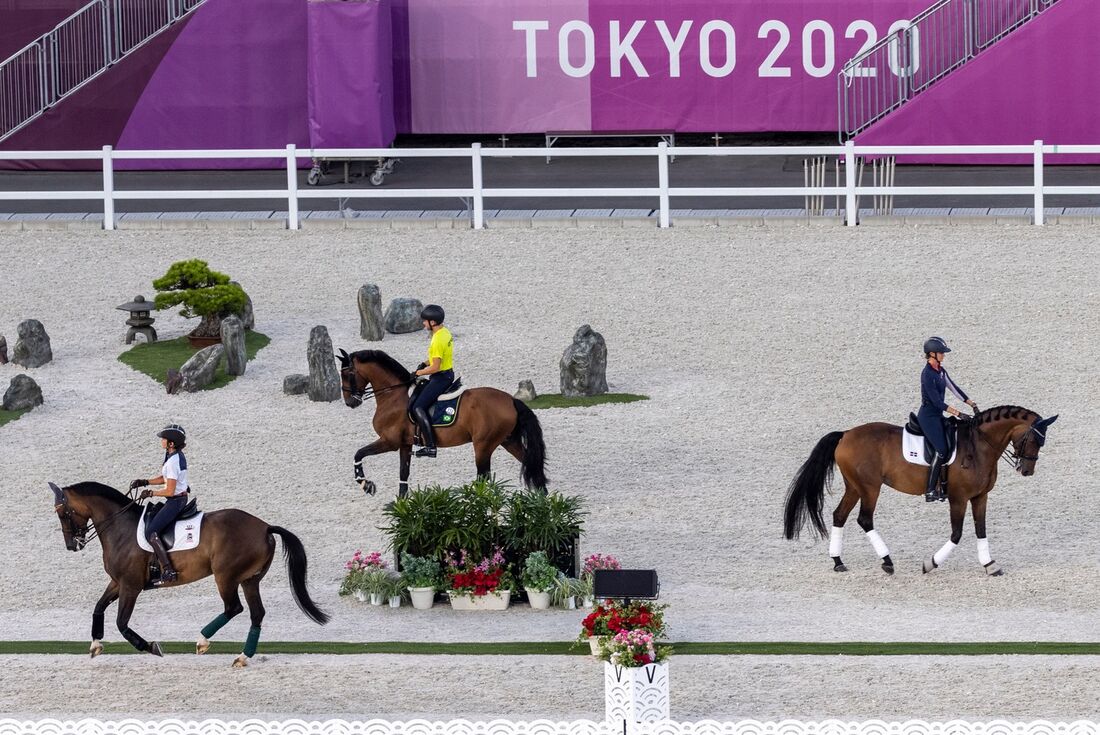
<box><xmin>0</xmin><ymin>718</ymin><xmax>1100</xmax><ymax>735</ymax></box>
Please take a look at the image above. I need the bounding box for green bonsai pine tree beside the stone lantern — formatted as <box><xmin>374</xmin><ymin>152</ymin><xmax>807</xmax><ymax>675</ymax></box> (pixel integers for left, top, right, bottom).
<box><xmin>153</xmin><ymin>260</ymin><xmax>248</xmax><ymax>337</ymax></box>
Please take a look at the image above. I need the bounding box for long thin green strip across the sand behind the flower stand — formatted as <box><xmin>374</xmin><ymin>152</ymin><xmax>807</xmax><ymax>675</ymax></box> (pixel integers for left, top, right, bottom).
<box><xmin>0</xmin><ymin>636</ymin><xmax>1100</xmax><ymax>656</ymax></box>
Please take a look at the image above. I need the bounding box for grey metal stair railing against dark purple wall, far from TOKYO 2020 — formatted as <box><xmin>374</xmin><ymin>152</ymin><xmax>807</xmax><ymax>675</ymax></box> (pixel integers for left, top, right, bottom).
<box><xmin>0</xmin><ymin>0</ymin><xmax>206</xmax><ymax>142</ymax></box>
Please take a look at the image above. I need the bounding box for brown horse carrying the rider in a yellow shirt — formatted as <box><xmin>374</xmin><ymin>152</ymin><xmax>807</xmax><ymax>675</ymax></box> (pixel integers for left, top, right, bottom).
<box><xmin>338</xmin><ymin>350</ymin><xmax>547</xmax><ymax>497</ymax></box>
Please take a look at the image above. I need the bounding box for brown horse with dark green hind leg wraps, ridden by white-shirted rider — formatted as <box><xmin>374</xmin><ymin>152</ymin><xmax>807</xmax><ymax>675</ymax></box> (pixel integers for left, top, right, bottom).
<box><xmin>50</xmin><ymin>482</ymin><xmax>329</xmax><ymax>668</ymax></box>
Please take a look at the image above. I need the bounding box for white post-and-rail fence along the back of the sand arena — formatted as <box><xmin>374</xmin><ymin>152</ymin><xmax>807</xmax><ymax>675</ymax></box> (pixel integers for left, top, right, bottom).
<box><xmin>0</xmin><ymin>141</ymin><xmax>1100</xmax><ymax>230</ymax></box>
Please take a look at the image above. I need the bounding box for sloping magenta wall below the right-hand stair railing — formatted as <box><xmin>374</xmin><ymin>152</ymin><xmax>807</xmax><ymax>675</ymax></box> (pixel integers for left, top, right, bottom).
<box><xmin>858</xmin><ymin>0</ymin><xmax>1100</xmax><ymax>164</ymax></box>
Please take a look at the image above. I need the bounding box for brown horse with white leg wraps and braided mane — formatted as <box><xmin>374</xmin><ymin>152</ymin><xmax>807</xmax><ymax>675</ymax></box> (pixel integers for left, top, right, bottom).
<box><xmin>783</xmin><ymin>406</ymin><xmax>1058</xmax><ymax>577</ymax></box>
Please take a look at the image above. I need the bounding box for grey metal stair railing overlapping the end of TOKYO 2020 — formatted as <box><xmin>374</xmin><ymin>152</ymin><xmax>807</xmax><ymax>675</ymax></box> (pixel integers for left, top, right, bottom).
<box><xmin>837</xmin><ymin>0</ymin><xmax>1058</xmax><ymax>142</ymax></box>
